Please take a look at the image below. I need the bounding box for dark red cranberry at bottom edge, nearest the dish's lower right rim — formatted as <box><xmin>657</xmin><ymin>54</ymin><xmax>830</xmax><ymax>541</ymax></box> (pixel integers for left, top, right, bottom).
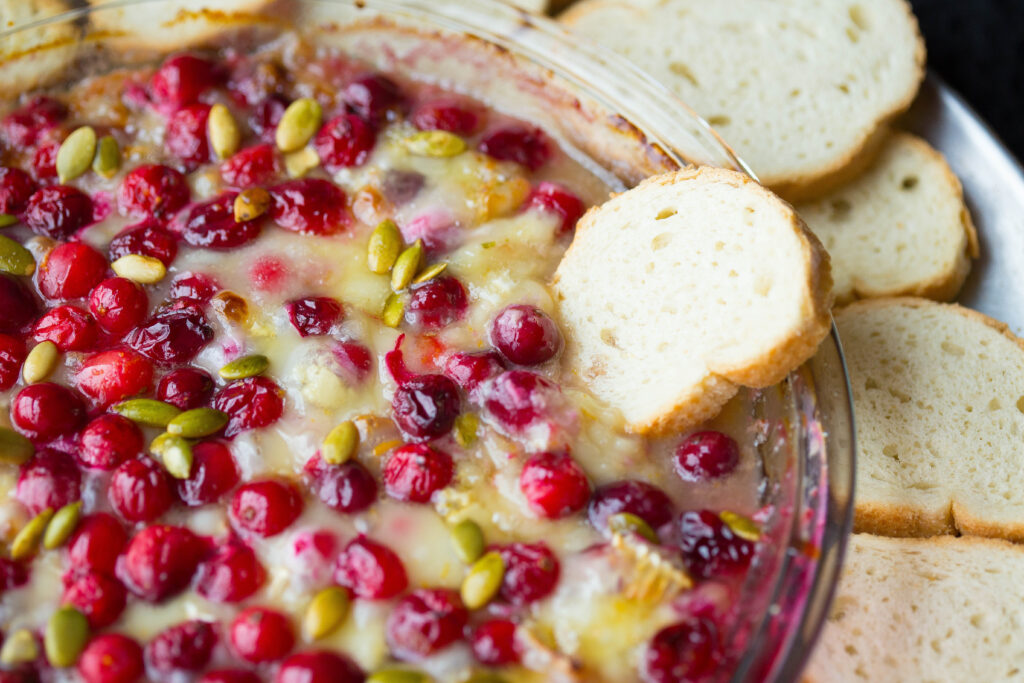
<box><xmin>640</xmin><ymin>618</ymin><xmax>719</xmax><ymax>683</ymax></box>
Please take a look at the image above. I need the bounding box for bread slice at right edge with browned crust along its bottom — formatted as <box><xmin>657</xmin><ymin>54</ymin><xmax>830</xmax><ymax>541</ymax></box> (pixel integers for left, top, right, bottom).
<box><xmin>836</xmin><ymin>298</ymin><xmax>1024</xmax><ymax>541</ymax></box>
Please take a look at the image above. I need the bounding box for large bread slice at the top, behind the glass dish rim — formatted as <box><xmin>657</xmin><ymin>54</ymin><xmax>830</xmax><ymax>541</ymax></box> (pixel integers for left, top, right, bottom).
<box><xmin>560</xmin><ymin>0</ymin><xmax>925</xmax><ymax>201</ymax></box>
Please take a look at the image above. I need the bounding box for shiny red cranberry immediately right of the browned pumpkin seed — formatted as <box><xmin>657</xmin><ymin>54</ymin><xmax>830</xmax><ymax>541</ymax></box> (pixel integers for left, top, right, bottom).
<box><xmin>269</xmin><ymin>178</ymin><xmax>349</xmax><ymax>234</ymax></box>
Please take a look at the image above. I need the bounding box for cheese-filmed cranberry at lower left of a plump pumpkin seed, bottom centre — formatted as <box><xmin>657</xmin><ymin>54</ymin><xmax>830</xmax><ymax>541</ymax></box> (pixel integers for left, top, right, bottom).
<box><xmin>387</xmin><ymin>588</ymin><xmax>469</xmax><ymax>659</ymax></box>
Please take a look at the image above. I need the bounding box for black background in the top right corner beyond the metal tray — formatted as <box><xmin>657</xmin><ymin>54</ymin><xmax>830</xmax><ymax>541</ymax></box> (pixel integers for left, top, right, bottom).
<box><xmin>910</xmin><ymin>0</ymin><xmax>1024</xmax><ymax>160</ymax></box>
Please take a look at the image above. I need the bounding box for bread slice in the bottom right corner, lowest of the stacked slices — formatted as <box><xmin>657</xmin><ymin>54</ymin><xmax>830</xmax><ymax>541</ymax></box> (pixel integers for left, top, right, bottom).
<box><xmin>803</xmin><ymin>535</ymin><xmax>1024</xmax><ymax>683</ymax></box>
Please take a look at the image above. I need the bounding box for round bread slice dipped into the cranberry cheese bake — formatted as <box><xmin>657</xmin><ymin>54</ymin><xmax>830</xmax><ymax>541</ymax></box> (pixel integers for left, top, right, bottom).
<box><xmin>554</xmin><ymin>168</ymin><xmax>831</xmax><ymax>433</ymax></box>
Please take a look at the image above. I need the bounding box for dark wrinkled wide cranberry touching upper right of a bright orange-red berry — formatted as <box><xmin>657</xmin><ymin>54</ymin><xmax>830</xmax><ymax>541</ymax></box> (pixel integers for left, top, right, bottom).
<box><xmin>125</xmin><ymin>306</ymin><xmax>213</xmax><ymax>362</ymax></box>
